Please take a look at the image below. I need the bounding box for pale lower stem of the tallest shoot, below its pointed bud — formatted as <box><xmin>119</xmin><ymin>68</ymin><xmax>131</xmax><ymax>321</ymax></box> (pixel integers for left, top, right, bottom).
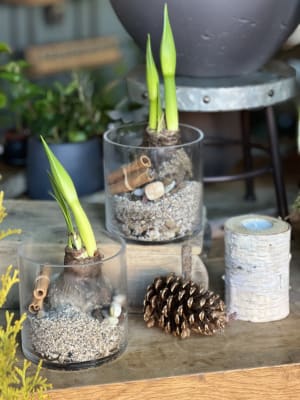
<box><xmin>164</xmin><ymin>76</ymin><xmax>178</xmax><ymax>131</ymax></box>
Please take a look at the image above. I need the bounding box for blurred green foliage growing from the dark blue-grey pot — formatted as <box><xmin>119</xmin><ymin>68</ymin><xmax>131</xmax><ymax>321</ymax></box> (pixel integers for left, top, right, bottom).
<box><xmin>29</xmin><ymin>73</ymin><xmax>104</xmax><ymax>143</ymax></box>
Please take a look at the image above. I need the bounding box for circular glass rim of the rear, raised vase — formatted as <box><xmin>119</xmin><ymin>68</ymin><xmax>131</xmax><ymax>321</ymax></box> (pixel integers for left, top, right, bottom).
<box><xmin>103</xmin><ymin>122</ymin><xmax>204</xmax><ymax>151</ymax></box>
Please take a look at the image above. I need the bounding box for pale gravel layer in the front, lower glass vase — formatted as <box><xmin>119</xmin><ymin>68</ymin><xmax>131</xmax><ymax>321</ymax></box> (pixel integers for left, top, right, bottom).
<box><xmin>30</xmin><ymin>307</ymin><xmax>125</xmax><ymax>364</ymax></box>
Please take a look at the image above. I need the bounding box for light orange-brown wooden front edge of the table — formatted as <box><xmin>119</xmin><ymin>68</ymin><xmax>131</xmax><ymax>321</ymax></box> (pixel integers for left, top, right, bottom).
<box><xmin>50</xmin><ymin>365</ymin><xmax>300</xmax><ymax>400</ymax></box>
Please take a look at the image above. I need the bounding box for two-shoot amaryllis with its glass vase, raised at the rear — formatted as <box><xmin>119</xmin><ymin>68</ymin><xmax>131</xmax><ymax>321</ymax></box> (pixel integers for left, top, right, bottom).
<box><xmin>104</xmin><ymin>5</ymin><xmax>203</xmax><ymax>242</ymax></box>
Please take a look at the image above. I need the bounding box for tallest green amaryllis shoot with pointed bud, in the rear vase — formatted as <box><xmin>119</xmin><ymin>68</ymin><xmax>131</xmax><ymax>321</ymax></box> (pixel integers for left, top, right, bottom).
<box><xmin>160</xmin><ymin>4</ymin><xmax>178</xmax><ymax>131</ymax></box>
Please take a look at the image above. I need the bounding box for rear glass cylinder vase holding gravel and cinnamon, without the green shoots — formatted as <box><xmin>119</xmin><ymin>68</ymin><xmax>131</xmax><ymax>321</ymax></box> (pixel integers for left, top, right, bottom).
<box><xmin>104</xmin><ymin>123</ymin><xmax>203</xmax><ymax>243</ymax></box>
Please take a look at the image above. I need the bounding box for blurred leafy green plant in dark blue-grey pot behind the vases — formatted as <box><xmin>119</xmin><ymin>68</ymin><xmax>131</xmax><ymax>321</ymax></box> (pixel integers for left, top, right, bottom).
<box><xmin>26</xmin><ymin>73</ymin><xmax>105</xmax><ymax>199</ymax></box>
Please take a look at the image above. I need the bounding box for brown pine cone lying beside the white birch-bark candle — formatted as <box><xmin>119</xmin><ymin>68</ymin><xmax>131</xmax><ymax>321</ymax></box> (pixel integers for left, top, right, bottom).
<box><xmin>144</xmin><ymin>274</ymin><xmax>227</xmax><ymax>339</ymax></box>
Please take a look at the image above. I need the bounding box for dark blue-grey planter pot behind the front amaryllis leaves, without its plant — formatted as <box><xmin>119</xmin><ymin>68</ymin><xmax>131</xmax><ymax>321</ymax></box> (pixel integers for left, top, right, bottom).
<box><xmin>26</xmin><ymin>137</ymin><xmax>104</xmax><ymax>200</ymax></box>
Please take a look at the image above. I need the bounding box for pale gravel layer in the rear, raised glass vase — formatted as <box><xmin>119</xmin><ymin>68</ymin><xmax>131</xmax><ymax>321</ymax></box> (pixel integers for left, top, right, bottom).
<box><xmin>112</xmin><ymin>181</ymin><xmax>202</xmax><ymax>242</ymax></box>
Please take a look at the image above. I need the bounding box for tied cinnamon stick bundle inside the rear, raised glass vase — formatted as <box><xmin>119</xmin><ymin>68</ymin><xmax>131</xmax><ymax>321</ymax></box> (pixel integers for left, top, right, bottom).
<box><xmin>109</xmin><ymin>169</ymin><xmax>154</xmax><ymax>194</ymax></box>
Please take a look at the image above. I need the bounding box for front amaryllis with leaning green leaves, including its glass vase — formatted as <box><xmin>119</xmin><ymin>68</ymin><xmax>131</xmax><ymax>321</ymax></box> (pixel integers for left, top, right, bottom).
<box><xmin>18</xmin><ymin>138</ymin><xmax>127</xmax><ymax>369</ymax></box>
